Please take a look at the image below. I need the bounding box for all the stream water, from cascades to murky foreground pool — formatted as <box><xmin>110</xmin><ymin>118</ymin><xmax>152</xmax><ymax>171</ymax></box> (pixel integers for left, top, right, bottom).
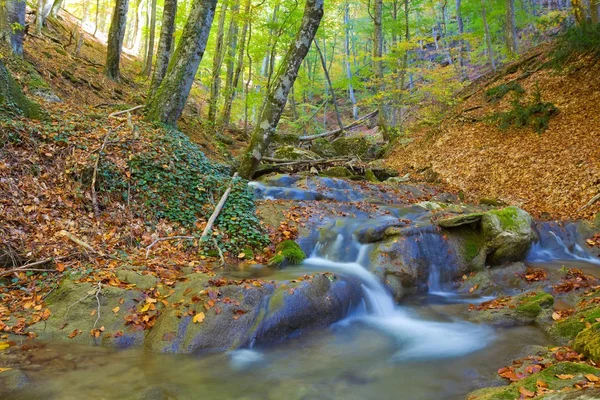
<box><xmin>0</xmin><ymin>183</ymin><xmax>597</xmax><ymax>400</ymax></box>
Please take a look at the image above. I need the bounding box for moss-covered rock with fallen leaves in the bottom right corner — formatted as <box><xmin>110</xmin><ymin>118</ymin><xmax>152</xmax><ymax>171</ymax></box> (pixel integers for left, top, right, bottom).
<box><xmin>466</xmin><ymin>361</ymin><xmax>600</xmax><ymax>400</ymax></box>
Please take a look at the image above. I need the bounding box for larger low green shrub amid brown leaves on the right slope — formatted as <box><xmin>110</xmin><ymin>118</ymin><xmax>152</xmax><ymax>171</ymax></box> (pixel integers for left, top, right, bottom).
<box><xmin>489</xmin><ymin>85</ymin><xmax>558</xmax><ymax>133</ymax></box>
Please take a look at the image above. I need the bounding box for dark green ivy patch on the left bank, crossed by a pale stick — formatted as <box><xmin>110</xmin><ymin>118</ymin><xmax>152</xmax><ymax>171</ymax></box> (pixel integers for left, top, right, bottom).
<box><xmin>124</xmin><ymin>130</ymin><xmax>267</xmax><ymax>251</ymax></box>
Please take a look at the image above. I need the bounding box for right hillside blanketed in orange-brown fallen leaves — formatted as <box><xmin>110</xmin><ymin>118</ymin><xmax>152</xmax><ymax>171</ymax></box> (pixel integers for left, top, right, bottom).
<box><xmin>387</xmin><ymin>52</ymin><xmax>600</xmax><ymax>219</ymax></box>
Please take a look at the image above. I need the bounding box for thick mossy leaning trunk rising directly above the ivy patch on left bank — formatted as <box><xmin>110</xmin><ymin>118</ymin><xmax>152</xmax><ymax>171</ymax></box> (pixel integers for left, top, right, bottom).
<box><xmin>146</xmin><ymin>0</ymin><xmax>217</xmax><ymax>126</ymax></box>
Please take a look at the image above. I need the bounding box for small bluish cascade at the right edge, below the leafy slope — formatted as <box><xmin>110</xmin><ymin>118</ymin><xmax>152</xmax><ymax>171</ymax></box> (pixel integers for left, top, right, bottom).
<box><xmin>527</xmin><ymin>222</ymin><xmax>600</xmax><ymax>265</ymax></box>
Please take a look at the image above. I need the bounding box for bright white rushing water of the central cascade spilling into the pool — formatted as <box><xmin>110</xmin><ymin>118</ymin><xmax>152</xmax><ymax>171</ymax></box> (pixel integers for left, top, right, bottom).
<box><xmin>304</xmin><ymin>239</ymin><xmax>495</xmax><ymax>360</ymax></box>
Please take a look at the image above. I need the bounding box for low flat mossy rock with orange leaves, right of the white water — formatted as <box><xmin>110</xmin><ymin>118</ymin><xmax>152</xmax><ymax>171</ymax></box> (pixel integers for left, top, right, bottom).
<box><xmin>469</xmin><ymin>292</ymin><xmax>554</xmax><ymax>326</ymax></box>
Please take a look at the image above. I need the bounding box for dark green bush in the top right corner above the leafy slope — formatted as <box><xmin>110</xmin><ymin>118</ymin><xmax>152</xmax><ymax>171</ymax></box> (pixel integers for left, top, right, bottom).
<box><xmin>548</xmin><ymin>23</ymin><xmax>600</xmax><ymax>69</ymax></box>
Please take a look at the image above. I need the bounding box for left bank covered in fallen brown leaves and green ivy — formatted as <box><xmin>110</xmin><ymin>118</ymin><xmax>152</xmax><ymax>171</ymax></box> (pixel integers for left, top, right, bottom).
<box><xmin>0</xmin><ymin>104</ymin><xmax>275</xmax><ymax>334</ymax></box>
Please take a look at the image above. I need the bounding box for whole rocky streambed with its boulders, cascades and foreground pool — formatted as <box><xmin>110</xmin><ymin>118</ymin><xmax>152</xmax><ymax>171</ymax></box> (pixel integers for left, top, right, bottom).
<box><xmin>0</xmin><ymin>175</ymin><xmax>600</xmax><ymax>399</ymax></box>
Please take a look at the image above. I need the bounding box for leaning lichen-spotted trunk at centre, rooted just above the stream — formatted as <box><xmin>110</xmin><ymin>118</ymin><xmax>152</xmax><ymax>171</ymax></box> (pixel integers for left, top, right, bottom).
<box><xmin>238</xmin><ymin>0</ymin><xmax>323</xmax><ymax>179</ymax></box>
